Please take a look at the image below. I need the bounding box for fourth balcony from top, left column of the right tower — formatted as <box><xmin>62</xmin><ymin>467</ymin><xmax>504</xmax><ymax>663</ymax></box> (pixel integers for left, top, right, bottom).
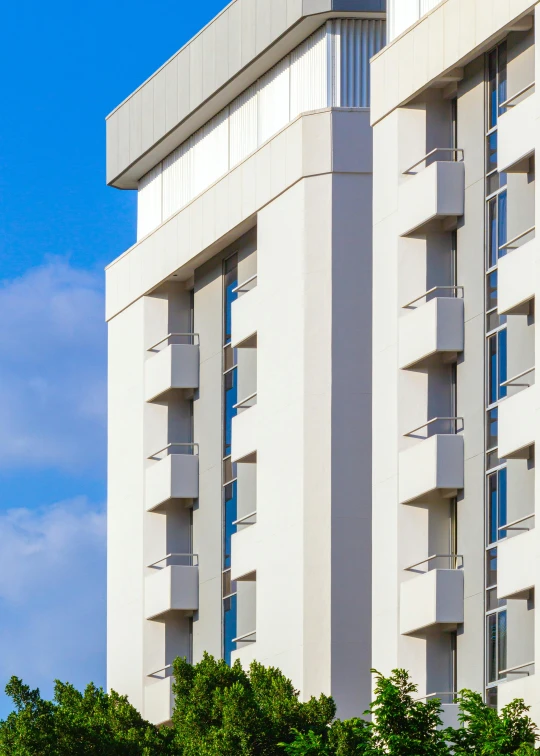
<box><xmin>399</xmin><ymin>569</ymin><xmax>464</xmax><ymax>635</ymax></box>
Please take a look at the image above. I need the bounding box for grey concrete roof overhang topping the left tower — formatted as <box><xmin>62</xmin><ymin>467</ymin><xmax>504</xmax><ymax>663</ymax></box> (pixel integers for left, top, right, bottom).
<box><xmin>106</xmin><ymin>0</ymin><xmax>386</xmax><ymax>189</ymax></box>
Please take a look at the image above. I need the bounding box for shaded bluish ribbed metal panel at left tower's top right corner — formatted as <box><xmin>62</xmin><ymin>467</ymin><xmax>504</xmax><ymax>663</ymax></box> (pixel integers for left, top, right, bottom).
<box><xmin>327</xmin><ymin>19</ymin><xmax>386</xmax><ymax>108</ymax></box>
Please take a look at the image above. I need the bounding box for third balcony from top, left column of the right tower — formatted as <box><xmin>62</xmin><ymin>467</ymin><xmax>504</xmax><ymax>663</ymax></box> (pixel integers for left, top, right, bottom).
<box><xmin>399</xmin><ymin>434</ymin><xmax>464</xmax><ymax>504</ymax></box>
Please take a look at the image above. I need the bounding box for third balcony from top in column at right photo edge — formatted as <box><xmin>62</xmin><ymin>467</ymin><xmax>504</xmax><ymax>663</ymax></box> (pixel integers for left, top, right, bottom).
<box><xmin>499</xmin><ymin>384</ymin><xmax>537</xmax><ymax>459</ymax></box>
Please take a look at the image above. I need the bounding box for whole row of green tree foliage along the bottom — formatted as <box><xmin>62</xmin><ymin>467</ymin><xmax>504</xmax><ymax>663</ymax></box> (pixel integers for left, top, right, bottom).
<box><xmin>0</xmin><ymin>654</ymin><xmax>538</xmax><ymax>756</ymax></box>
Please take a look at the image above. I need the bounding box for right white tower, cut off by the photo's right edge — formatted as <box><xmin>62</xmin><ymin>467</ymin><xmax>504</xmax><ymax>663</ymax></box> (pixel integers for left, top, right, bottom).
<box><xmin>371</xmin><ymin>0</ymin><xmax>540</xmax><ymax>722</ymax></box>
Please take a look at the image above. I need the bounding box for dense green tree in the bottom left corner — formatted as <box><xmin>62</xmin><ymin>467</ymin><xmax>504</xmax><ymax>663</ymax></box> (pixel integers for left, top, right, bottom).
<box><xmin>0</xmin><ymin>677</ymin><xmax>172</xmax><ymax>756</ymax></box>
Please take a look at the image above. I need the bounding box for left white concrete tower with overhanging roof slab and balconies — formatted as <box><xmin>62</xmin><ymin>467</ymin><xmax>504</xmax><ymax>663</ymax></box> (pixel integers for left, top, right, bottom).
<box><xmin>106</xmin><ymin>0</ymin><xmax>385</xmax><ymax>723</ymax></box>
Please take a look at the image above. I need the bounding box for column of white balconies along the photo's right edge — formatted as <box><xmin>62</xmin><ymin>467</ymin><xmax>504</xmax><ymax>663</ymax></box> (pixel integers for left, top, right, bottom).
<box><xmin>497</xmin><ymin>83</ymin><xmax>539</xmax><ymax>714</ymax></box>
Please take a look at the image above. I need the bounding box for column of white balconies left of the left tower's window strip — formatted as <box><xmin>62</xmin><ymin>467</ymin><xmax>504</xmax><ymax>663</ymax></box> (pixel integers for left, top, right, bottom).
<box><xmin>144</xmin><ymin>333</ymin><xmax>199</xmax><ymax>724</ymax></box>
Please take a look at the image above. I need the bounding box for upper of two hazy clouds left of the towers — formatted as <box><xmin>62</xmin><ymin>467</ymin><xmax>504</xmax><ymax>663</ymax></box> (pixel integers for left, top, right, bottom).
<box><xmin>0</xmin><ymin>257</ymin><xmax>106</xmax><ymax>472</ymax></box>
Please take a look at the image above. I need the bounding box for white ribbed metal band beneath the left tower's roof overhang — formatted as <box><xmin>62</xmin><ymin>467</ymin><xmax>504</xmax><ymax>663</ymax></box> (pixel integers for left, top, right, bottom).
<box><xmin>137</xmin><ymin>19</ymin><xmax>386</xmax><ymax>239</ymax></box>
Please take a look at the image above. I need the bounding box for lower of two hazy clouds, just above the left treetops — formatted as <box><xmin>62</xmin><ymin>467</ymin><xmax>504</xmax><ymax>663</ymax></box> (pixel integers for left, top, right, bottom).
<box><xmin>0</xmin><ymin>497</ymin><xmax>106</xmax><ymax>716</ymax></box>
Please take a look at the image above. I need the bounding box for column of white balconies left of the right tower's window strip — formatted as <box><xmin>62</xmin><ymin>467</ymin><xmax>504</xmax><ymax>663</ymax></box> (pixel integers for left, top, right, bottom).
<box><xmin>398</xmin><ymin>149</ymin><xmax>465</xmax><ymax>672</ymax></box>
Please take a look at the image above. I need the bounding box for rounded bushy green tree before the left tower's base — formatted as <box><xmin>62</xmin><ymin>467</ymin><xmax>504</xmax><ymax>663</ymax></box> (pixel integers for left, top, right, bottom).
<box><xmin>173</xmin><ymin>654</ymin><xmax>336</xmax><ymax>756</ymax></box>
